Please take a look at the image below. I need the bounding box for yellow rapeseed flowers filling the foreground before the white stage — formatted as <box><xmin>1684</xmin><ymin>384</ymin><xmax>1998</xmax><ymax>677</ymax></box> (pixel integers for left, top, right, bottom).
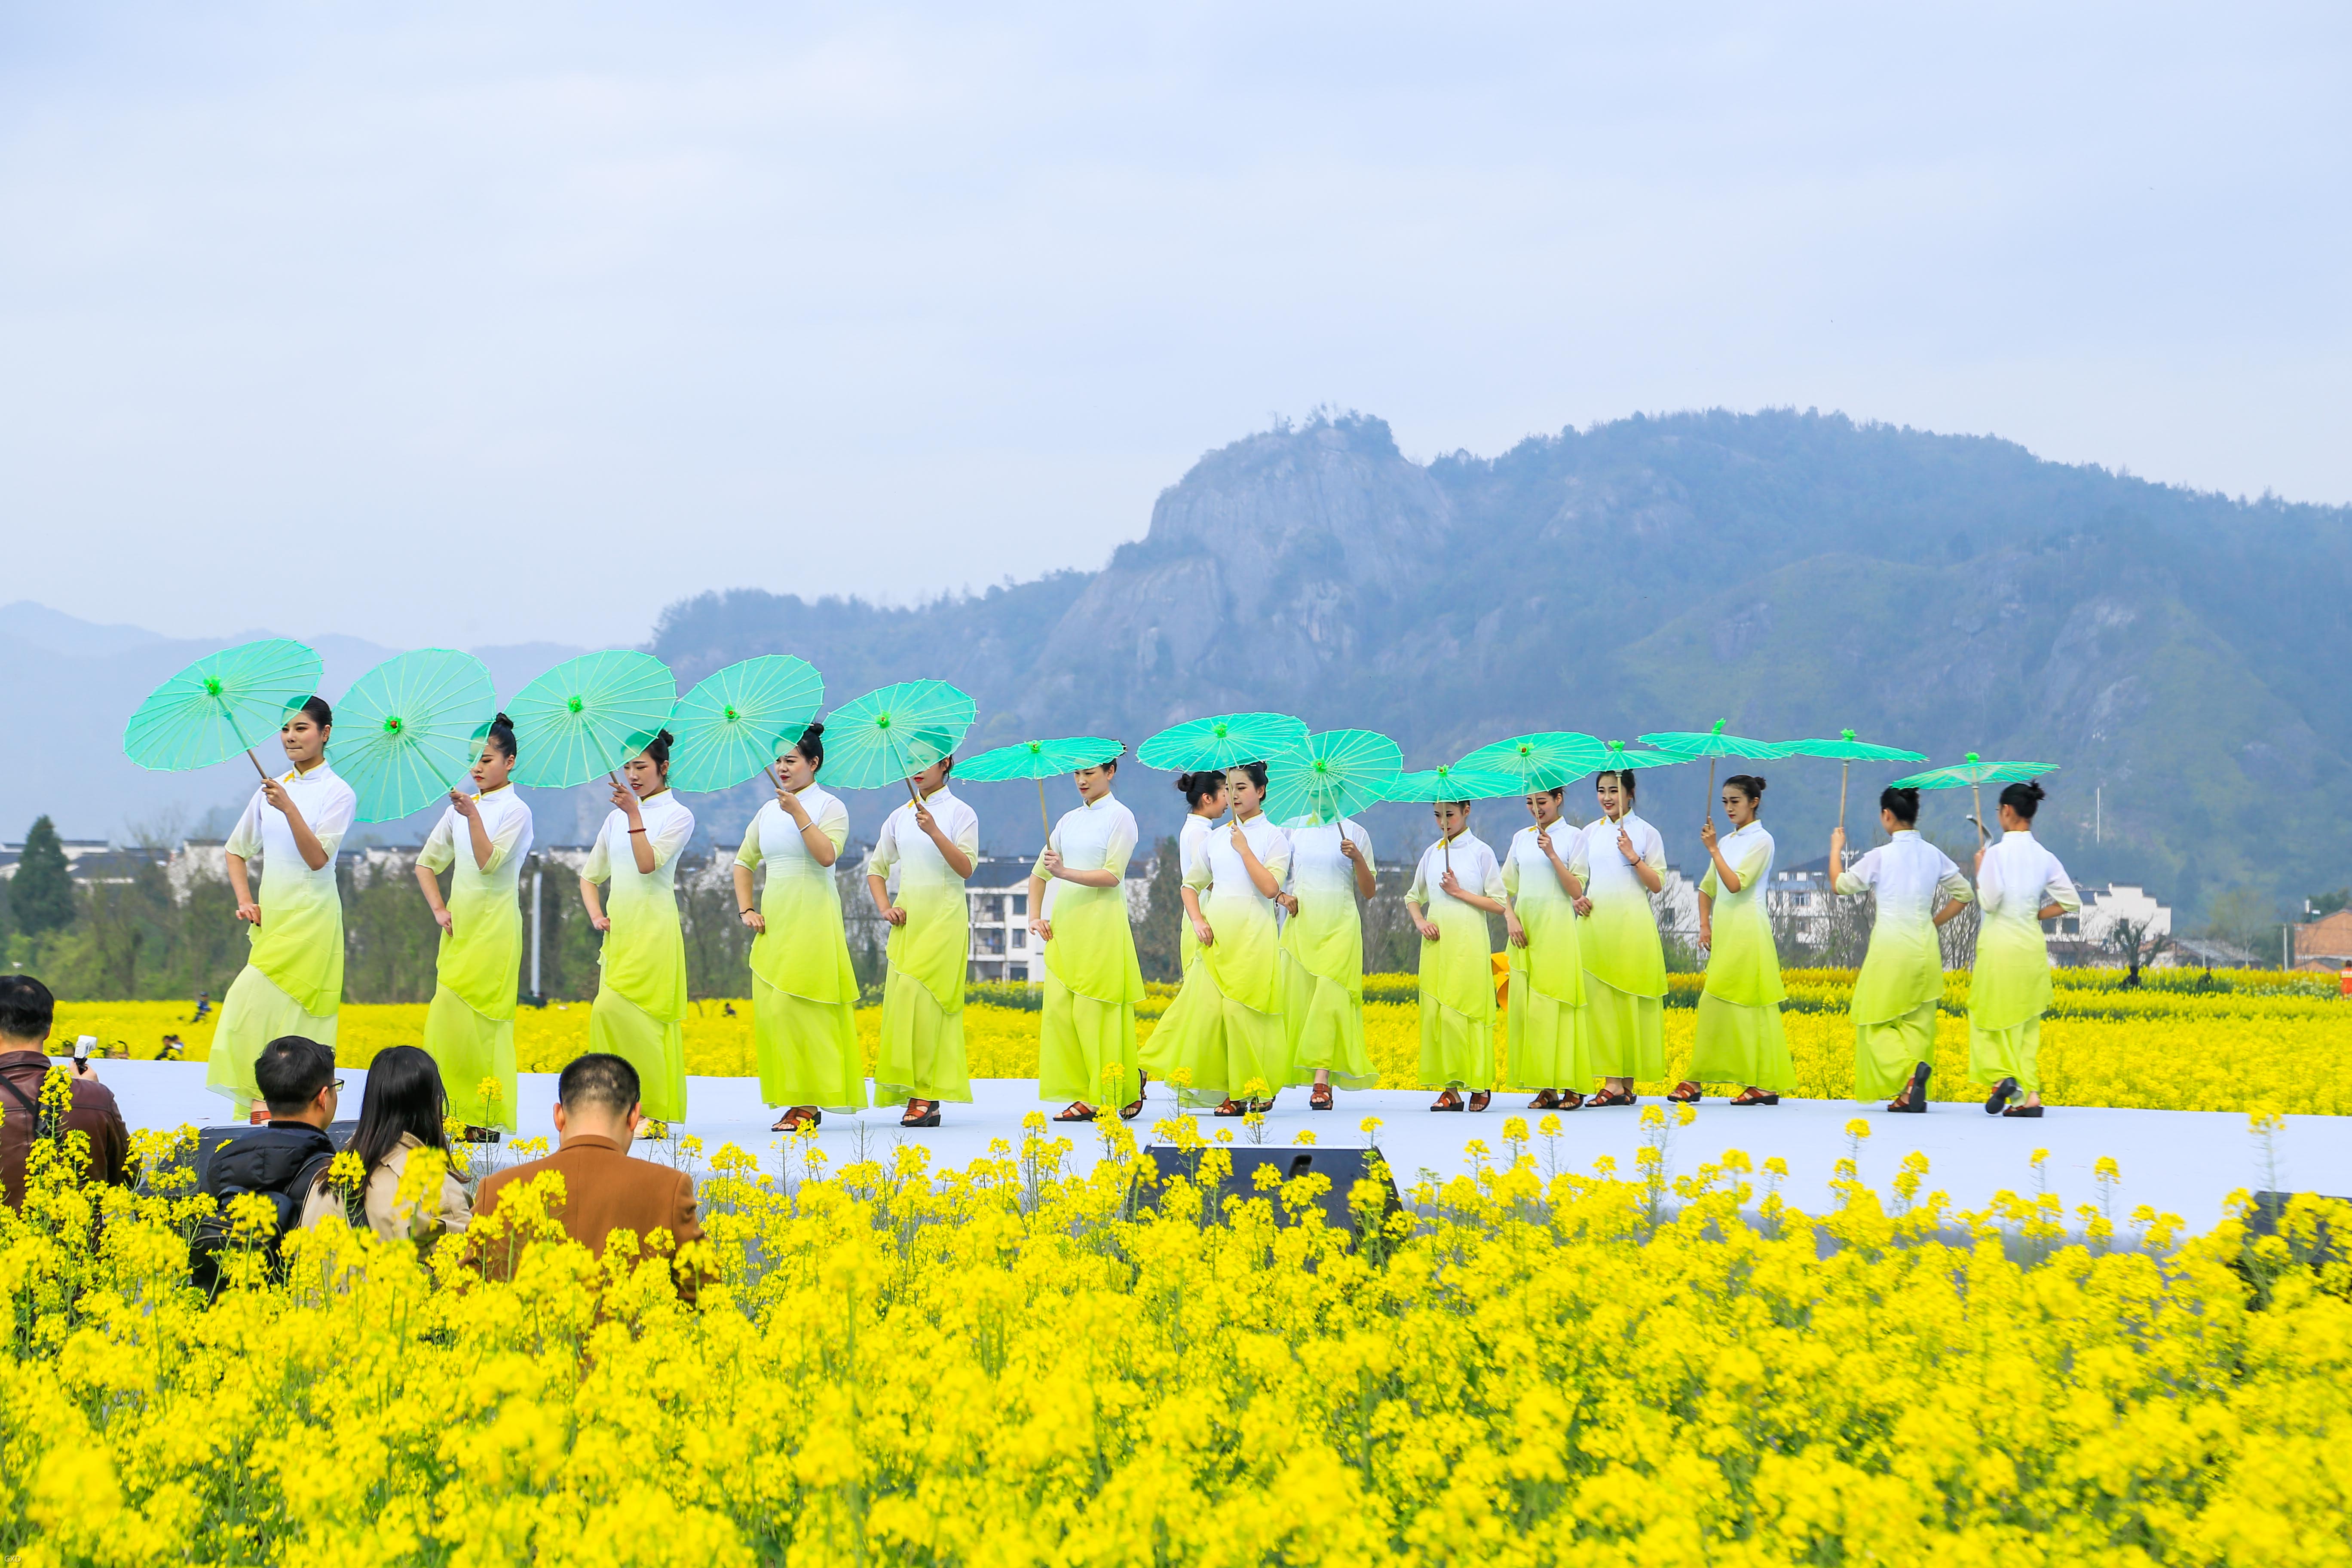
<box><xmin>0</xmin><ymin>1072</ymin><xmax>2352</xmax><ymax>1568</ymax></box>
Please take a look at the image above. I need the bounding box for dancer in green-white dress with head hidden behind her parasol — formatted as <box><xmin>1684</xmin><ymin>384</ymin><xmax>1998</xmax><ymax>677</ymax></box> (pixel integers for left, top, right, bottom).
<box><xmin>1277</xmin><ymin>816</ymin><xmax>1381</xmax><ymax>1109</ymax></box>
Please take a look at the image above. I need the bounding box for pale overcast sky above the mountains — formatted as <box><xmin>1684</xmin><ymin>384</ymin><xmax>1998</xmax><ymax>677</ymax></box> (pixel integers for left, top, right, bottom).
<box><xmin>0</xmin><ymin>0</ymin><xmax>2352</xmax><ymax>644</ymax></box>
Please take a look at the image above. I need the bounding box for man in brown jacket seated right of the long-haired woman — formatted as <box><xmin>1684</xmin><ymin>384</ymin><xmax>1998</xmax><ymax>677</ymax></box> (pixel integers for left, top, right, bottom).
<box><xmin>473</xmin><ymin>1053</ymin><xmax>703</xmax><ymax>1300</ymax></box>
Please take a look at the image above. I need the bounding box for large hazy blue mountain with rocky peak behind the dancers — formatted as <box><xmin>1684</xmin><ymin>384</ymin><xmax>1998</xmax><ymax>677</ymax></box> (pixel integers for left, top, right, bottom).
<box><xmin>654</xmin><ymin>411</ymin><xmax>2352</xmax><ymax>910</ymax></box>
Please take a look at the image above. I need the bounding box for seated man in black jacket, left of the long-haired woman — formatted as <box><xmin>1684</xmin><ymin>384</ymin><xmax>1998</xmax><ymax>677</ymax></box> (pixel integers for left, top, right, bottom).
<box><xmin>188</xmin><ymin>1034</ymin><xmax>343</xmax><ymax>1293</ymax></box>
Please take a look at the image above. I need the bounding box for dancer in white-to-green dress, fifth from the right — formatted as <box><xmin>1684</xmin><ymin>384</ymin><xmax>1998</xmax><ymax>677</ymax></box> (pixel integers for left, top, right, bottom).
<box><xmin>1503</xmin><ymin>790</ymin><xmax>1597</xmax><ymax>1109</ymax></box>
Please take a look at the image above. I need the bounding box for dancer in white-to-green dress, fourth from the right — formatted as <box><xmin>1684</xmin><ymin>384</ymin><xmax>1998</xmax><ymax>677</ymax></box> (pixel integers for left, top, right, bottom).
<box><xmin>1569</xmin><ymin>769</ymin><xmax>1665</xmax><ymax>1109</ymax></box>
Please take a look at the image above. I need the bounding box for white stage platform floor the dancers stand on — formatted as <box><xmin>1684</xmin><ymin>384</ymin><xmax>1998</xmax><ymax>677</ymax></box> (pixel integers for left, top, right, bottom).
<box><xmin>83</xmin><ymin>1060</ymin><xmax>2352</xmax><ymax>1229</ymax></box>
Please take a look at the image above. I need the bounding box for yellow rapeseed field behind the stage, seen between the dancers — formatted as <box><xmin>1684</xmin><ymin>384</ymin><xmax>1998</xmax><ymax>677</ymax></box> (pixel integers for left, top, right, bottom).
<box><xmin>56</xmin><ymin>968</ymin><xmax>2352</xmax><ymax>1117</ymax></box>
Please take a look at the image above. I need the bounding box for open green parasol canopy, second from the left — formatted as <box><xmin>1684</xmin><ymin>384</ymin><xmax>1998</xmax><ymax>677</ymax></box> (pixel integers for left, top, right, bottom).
<box><xmin>334</xmin><ymin>649</ymin><xmax>499</xmax><ymax>823</ymax></box>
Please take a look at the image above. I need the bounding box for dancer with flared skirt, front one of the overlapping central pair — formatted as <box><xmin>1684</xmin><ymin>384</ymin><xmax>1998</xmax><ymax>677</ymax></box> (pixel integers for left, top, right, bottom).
<box><xmin>1143</xmin><ymin>762</ymin><xmax>1291</xmax><ymax>1117</ymax></box>
